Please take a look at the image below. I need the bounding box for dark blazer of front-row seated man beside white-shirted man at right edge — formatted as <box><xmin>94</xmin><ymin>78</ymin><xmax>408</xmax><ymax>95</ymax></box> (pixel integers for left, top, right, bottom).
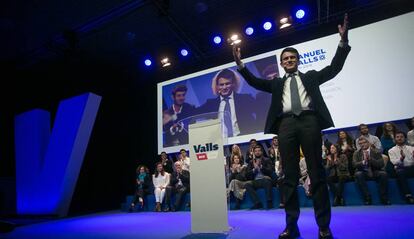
<box><xmin>352</xmin><ymin>148</ymin><xmax>384</xmax><ymax>176</ymax></box>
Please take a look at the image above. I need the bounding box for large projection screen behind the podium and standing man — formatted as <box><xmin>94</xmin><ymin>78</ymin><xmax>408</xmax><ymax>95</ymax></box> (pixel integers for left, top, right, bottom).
<box><xmin>157</xmin><ymin>12</ymin><xmax>414</xmax><ymax>153</ymax></box>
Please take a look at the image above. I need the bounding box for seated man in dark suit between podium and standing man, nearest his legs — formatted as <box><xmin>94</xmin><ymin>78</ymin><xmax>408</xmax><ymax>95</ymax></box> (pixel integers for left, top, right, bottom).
<box><xmin>245</xmin><ymin>145</ymin><xmax>273</xmax><ymax>209</ymax></box>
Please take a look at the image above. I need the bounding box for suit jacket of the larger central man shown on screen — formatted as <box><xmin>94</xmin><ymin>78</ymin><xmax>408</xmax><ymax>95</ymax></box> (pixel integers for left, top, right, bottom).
<box><xmin>197</xmin><ymin>92</ymin><xmax>259</xmax><ymax>135</ymax></box>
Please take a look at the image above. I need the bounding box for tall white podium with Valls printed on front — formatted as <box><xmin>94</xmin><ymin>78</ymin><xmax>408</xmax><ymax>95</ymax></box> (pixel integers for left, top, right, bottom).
<box><xmin>188</xmin><ymin>112</ymin><xmax>229</xmax><ymax>233</ymax></box>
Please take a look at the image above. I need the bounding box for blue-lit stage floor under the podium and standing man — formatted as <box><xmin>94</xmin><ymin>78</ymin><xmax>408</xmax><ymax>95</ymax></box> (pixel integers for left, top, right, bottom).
<box><xmin>0</xmin><ymin>205</ymin><xmax>414</xmax><ymax>239</ymax></box>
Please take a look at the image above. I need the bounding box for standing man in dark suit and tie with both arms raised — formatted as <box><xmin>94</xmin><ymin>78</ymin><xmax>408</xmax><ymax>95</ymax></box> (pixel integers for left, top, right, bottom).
<box><xmin>233</xmin><ymin>15</ymin><xmax>351</xmax><ymax>238</ymax></box>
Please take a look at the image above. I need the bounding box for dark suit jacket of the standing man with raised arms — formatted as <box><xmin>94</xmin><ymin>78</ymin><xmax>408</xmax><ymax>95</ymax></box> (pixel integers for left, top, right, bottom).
<box><xmin>239</xmin><ymin>45</ymin><xmax>351</xmax><ymax>134</ymax></box>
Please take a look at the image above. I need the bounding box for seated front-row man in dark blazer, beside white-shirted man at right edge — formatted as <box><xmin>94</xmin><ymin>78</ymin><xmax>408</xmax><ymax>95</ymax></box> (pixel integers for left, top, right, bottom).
<box><xmin>352</xmin><ymin>137</ymin><xmax>391</xmax><ymax>205</ymax></box>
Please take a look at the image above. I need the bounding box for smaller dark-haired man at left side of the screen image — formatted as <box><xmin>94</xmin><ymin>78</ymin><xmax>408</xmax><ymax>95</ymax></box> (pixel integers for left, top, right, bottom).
<box><xmin>163</xmin><ymin>85</ymin><xmax>195</xmax><ymax>146</ymax></box>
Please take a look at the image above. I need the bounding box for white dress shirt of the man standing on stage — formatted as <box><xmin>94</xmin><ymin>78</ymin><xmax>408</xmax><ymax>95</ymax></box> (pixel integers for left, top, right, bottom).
<box><xmin>282</xmin><ymin>71</ymin><xmax>311</xmax><ymax>113</ymax></box>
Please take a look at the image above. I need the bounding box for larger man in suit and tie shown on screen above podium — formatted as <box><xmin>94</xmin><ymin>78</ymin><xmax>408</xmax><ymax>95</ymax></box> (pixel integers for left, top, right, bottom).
<box><xmin>197</xmin><ymin>69</ymin><xmax>258</xmax><ymax>137</ymax></box>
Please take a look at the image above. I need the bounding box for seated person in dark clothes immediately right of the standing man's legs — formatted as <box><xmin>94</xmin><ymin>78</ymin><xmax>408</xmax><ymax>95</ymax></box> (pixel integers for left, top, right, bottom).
<box><xmin>325</xmin><ymin>144</ymin><xmax>350</xmax><ymax>207</ymax></box>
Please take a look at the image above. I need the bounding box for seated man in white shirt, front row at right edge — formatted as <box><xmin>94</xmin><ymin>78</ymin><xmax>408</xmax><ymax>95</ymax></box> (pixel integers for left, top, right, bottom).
<box><xmin>388</xmin><ymin>132</ymin><xmax>414</xmax><ymax>204</ymax></box>
